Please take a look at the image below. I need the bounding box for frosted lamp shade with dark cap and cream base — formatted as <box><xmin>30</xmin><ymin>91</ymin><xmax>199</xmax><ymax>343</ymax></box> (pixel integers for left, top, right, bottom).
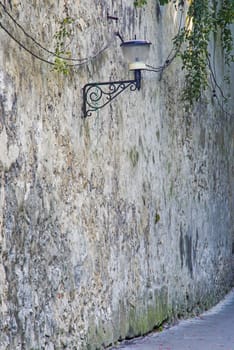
<box><xmin>120</xmin><ymin>40</ymin><xmax>151</xmax><ymax>70</ymax></box>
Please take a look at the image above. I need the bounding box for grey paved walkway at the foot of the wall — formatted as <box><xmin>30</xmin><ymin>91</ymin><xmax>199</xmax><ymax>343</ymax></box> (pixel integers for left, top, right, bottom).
<box><xmin>115</xmin><ymin>289</ymin><xmax>234</xmax><ymax>350</ymax></box>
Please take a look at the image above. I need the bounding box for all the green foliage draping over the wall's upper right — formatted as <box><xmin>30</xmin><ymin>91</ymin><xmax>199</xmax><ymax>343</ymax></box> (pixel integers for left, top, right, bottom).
<box><xmin>134</xmin><ymin>0</ymin><xmax>234</xmax><ymax>105</ymax></box>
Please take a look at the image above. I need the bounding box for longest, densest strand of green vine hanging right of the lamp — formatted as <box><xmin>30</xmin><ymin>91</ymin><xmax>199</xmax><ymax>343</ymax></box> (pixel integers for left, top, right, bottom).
<box><xmin>174</xmin><ymin>0</ymin><xmax>214</xmax><ymax>104</ymax></box>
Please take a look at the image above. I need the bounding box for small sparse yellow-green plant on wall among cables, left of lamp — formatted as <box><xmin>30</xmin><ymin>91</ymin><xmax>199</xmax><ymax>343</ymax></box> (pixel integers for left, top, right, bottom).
<box><xmin>53</xmin><ymin>17</ymin><xmax>74</xmax><ymax>75</ymax></box>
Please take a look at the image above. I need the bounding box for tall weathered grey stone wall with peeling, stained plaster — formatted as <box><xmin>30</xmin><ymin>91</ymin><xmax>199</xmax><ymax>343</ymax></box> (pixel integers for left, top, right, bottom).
<box><xmin>0</xmin><ymin>0</ymin><xmax>234</xmax><ymax>350</ymax></box>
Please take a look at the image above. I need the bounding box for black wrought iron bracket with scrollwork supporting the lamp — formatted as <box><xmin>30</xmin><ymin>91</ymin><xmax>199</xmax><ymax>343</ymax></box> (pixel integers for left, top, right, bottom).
<box><xmin>83</xmin><ymin>69</ymin><xmax>141</xmax><ymax>118</ymax></box>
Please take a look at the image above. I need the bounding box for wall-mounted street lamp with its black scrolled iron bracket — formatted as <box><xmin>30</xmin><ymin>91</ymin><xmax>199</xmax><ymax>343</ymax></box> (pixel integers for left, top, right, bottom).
<box><xmin>83</xmin><ymin>40</ymin><xmax>151</xmax><ymax>118</ymax></box>
